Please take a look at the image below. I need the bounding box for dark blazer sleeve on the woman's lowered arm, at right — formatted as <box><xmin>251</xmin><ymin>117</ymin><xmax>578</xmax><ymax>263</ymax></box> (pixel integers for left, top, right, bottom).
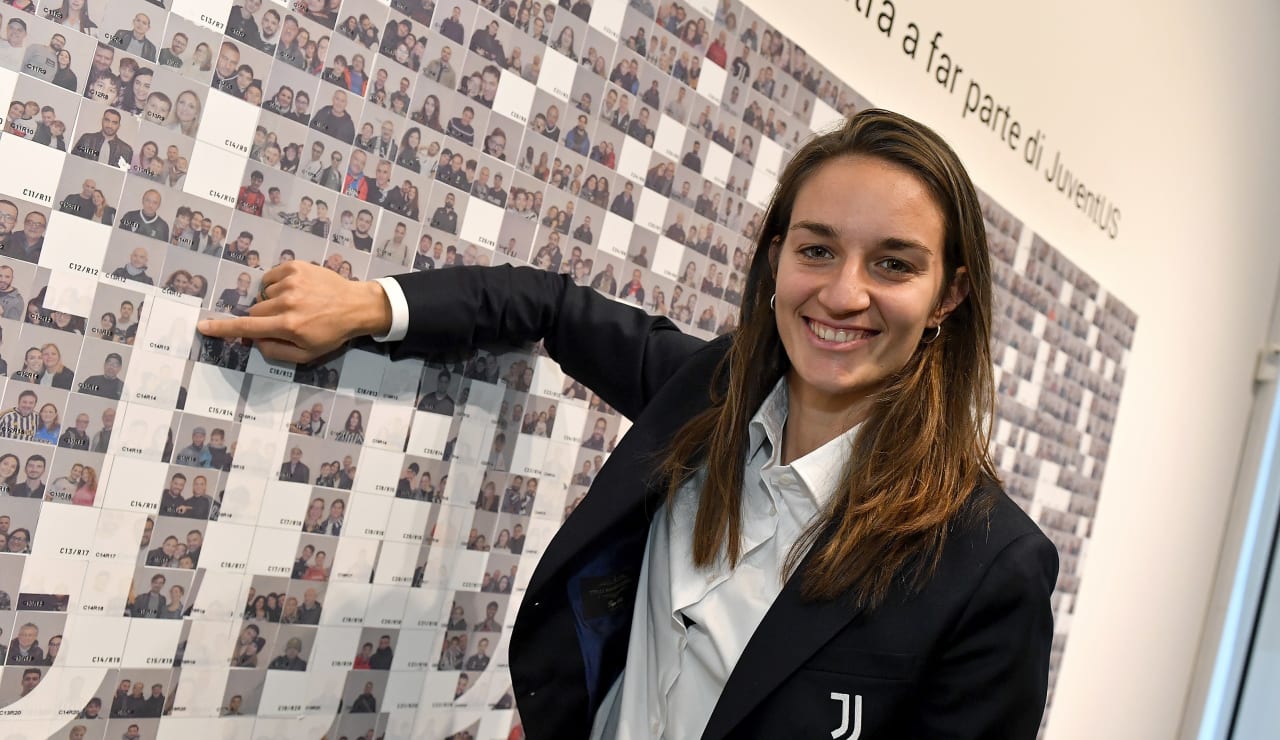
<box><xmin>911</xmin><ymin>530</ymin><xmax>1057</xmax><ymax>740</ymax></box>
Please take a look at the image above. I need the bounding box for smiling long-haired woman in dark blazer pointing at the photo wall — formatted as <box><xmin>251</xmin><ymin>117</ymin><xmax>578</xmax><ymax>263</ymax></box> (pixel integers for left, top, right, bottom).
<box><xmin>200</xmin><ymin>110</ymin><xmax>1057</xmax><ymax>740</ymax></box>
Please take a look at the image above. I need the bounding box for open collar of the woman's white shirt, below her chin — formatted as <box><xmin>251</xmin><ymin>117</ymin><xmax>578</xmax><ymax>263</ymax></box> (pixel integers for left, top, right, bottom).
<box><xmin>748</xmin><ymin>375</ymin><xmax>861</xmax><ymax>508</ymax></box>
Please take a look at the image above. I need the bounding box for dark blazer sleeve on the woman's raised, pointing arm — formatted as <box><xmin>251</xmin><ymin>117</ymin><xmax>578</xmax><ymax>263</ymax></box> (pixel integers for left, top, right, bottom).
<box><xmin>394</xmin><ymin>265</ymin><xmax>705</xmax><ymax>419</ymax></box>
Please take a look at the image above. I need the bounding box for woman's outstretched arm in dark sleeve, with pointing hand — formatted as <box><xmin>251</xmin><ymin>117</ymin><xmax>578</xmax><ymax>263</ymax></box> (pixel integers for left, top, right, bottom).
<box><xmin>200</xmin><ymin>261</ymin><xmax>704</xmax><ymax>419</ymax></box>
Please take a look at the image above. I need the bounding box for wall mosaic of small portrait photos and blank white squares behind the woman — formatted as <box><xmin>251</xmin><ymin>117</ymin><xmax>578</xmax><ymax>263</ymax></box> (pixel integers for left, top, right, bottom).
<box><xmin>0</xmin><ymin>0</ymin><xmax>1135</xmax><ymax>739</ymax></box>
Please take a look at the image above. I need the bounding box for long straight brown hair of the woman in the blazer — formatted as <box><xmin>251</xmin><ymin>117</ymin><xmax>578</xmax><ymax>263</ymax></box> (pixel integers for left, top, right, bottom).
<box><xmin>662</xmin><ymin>110</ymin><xmax>997</xmax><ymax>608</ymax></box>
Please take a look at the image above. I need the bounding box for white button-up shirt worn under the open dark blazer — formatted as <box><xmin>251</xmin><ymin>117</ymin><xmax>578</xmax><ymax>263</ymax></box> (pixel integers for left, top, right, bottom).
<box><xmin>591</xmin><ymin>379</ymin><xmax>858</xmax><ymax>740</ymax></box>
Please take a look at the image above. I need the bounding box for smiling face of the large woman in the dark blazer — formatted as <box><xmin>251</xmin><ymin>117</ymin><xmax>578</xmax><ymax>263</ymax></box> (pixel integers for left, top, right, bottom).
<box><xmin>772</xmin><ymin>156</ymin><xmax>968</xmax><ymax>417</ymax></box>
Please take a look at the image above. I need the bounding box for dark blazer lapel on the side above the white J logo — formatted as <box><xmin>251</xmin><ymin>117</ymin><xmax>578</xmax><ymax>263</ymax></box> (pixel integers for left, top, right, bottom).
<box><xmin>703</xmin><ymin>529</ymin><xmax>864</xmax><ymax>740</ymax></box>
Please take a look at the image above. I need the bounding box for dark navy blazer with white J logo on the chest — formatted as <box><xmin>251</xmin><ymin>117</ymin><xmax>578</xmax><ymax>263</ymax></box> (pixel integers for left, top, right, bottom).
<box><xmin>394</xmin><ymin>266</ymin><xmax>1057</xmax><ymax>740</ymax></box>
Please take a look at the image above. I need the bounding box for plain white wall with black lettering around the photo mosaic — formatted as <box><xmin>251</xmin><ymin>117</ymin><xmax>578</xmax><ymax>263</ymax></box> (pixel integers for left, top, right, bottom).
<box><xmin>748</xmin><ymin>0</ymin><xmax>1280</xmax><ymax>740</ymax></box>
